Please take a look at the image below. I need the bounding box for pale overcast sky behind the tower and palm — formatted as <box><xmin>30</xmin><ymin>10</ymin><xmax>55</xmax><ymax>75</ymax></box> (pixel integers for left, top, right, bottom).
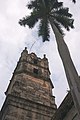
<box><xmin>0</xmin><ymin>0</ymin><xmax>80</xmax><ymax>108</ymax></box>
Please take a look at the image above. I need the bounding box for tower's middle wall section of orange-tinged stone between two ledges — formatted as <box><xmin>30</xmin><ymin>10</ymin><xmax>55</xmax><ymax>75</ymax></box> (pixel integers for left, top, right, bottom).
<box><xmin>8</xmin><ymin>73</ymin><xmax>55</xmax><ymax>106</ymax></box>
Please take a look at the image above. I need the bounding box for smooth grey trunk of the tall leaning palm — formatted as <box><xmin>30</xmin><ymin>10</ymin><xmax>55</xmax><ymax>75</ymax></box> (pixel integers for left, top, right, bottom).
<box><xmin>49</xmin><ymin>18</ymin><xmax>80</xmax><ymax>119</ymax></box>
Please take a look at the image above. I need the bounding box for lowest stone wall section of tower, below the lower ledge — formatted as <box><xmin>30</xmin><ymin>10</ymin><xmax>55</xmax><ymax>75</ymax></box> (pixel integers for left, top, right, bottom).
<box><xmin>0</xmin><ymin>95</ymin><xmax>55</xmax><ymax>120</ymax></box>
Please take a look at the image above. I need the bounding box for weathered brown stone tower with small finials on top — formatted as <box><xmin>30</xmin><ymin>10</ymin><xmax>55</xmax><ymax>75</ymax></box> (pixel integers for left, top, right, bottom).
<box><xmin>0</xmin><ymin>48</ymin><xmax>56</xmax><ymax>120</ymax></box>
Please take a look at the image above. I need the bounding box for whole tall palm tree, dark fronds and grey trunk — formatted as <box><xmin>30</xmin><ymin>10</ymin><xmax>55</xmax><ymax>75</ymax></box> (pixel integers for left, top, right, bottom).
<box><xmin>19</xmin><ymin>0</ymin><xmax>80</xmax><ymax>118</ymax></box>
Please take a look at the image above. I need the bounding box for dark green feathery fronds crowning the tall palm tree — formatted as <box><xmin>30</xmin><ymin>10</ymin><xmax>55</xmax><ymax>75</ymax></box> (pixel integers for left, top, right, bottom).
<box><xmin>19</xmin><ymin>0</ymin><xmax>74</xmax><ymax>42</ymax></box>
